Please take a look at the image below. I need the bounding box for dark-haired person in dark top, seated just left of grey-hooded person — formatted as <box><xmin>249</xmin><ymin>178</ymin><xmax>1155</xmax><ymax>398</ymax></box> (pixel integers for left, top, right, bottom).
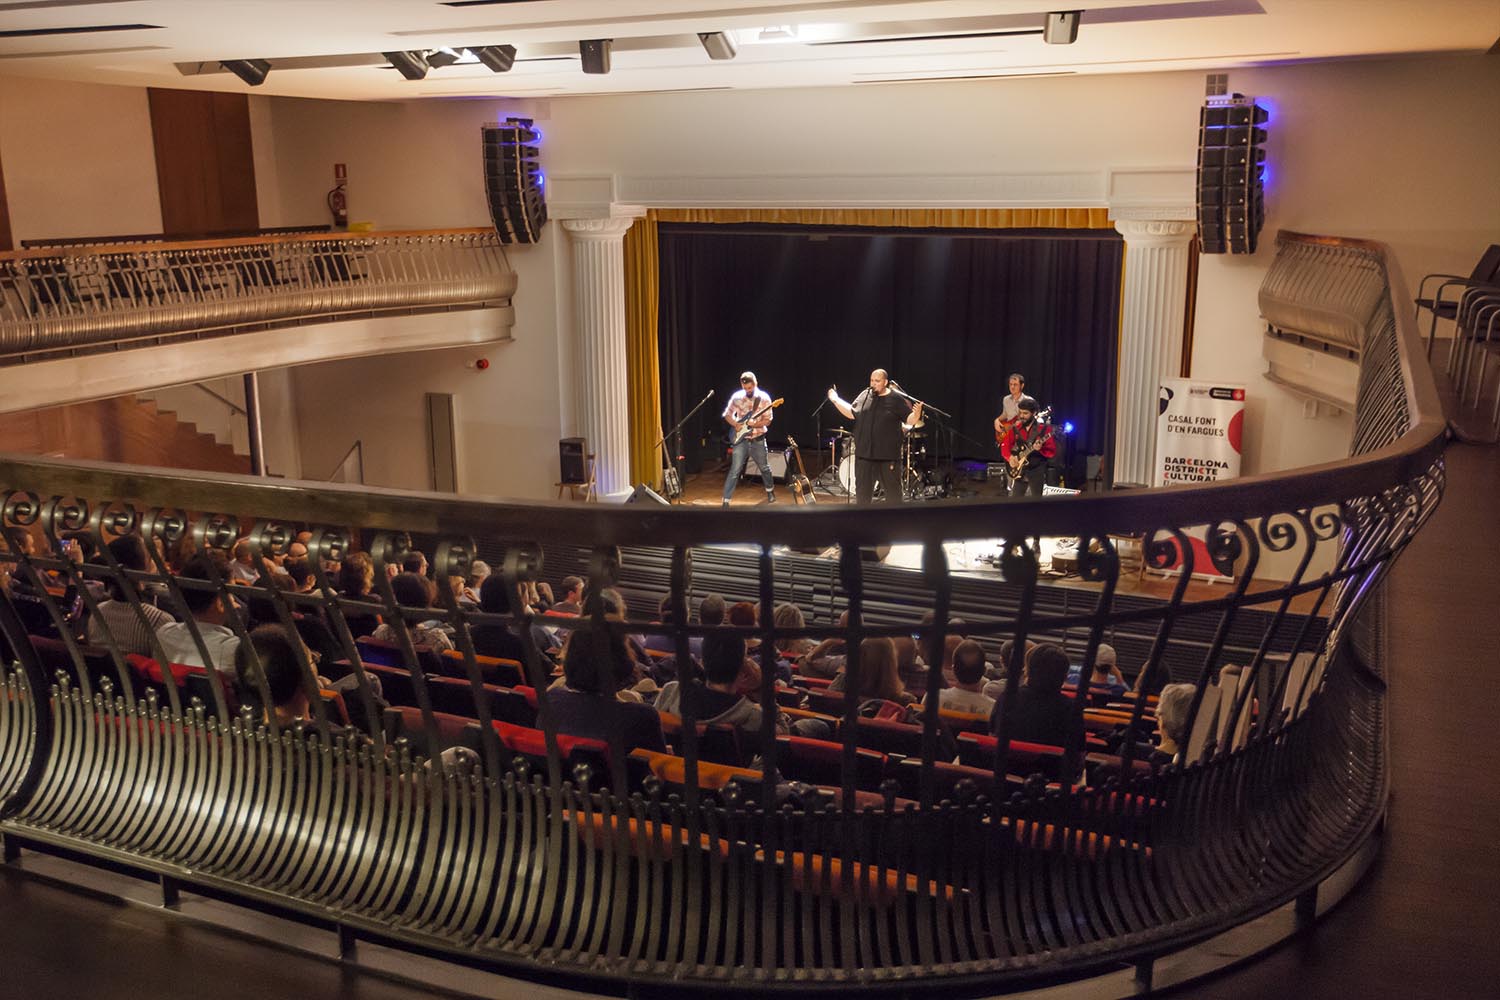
<box><xmin>548</xmin><ymin>622</ymin><xmax>666</xmax><ymax>754</ymax></box>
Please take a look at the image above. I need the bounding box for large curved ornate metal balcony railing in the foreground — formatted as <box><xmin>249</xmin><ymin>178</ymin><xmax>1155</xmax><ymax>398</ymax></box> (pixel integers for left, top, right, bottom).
<box><xmin>0</xmin><ymin>235</ymin><xmax>1443</xmax><ymax>993</ymax></box>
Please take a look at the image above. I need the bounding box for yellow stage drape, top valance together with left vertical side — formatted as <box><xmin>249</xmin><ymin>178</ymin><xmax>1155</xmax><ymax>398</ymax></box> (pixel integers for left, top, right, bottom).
<box><xmin>626</xmin><ymin>208</ymin><xmax>1112</xmax><ymax>489</ymax></box>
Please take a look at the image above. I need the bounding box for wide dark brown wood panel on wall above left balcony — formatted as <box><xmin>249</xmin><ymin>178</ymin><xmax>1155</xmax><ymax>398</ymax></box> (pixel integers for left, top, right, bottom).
<box><xmin>147</xmin><ymin>87</ymin><xmax>261</xmax><ymax>235</ymax></box>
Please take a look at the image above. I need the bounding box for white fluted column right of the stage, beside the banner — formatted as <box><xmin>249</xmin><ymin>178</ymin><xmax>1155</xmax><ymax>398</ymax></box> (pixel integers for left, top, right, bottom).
<box><xmin>1115</xmin><ymin>219</ymin><xmax>1197</xmax><ymax>486</ymax></box>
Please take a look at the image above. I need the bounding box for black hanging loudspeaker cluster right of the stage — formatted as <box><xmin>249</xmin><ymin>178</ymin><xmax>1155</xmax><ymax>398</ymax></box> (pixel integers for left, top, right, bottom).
<box><xmin>1199</xmin><ymin>94</ymin><xmax>1268</xmax><ymax>253</ymax></box>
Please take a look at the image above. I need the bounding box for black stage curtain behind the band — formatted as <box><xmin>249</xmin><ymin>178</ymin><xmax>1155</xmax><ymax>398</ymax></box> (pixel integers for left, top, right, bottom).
<box><xmin>659</xmin><ymin>223</ymin><xmax>1125</xmax><ymax>471</ymax></box>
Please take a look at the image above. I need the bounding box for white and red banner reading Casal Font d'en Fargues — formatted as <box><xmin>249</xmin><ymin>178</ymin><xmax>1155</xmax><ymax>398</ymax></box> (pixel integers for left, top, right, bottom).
<box><xmin>1152</xmin><ymin>378</ymin><xmax>1245</xmax><ymax>580</ymax></box>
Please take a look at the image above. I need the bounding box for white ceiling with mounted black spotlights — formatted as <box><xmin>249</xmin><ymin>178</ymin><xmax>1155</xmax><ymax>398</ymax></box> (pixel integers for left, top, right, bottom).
<box><xmin>0</xmin><ymin>0</ymin><xmax>1500</xmax><ymax>100</ymax></box>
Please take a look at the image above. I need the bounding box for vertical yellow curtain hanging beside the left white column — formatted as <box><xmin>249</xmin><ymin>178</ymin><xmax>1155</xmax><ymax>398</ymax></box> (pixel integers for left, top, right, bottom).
<box><xmin>626</xmin><ymin>214</ymin><xmax>662</xmax><ymax>490</ymax></box>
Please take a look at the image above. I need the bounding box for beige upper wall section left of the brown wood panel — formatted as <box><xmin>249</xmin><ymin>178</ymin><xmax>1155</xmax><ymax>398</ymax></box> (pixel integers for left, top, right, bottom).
<box><xmin>0</xmin><ymin>76</ymin><xmax>162</xmax><ymax>246</ymax></box>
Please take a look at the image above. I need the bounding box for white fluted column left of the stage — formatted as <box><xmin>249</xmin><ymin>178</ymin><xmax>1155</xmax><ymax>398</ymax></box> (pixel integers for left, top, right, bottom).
<box><xmin>563</xmin><ymin>216</ymin><xmax>635</xmax><ymax>501</ymax></box>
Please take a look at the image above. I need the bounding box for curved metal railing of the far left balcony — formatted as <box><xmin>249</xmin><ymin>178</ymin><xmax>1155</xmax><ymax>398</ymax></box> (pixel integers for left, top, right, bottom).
<box><xmin>0</xmin><ymin>229</ymin><xmax>516</xmax><ymax>364</ymax></box>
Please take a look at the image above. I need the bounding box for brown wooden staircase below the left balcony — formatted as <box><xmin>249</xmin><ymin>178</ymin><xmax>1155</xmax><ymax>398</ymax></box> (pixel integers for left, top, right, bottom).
<box><xmin>0</xmin><ymin>396</ymin><xmax>251</xmax><ymax>474</ymax></box>
